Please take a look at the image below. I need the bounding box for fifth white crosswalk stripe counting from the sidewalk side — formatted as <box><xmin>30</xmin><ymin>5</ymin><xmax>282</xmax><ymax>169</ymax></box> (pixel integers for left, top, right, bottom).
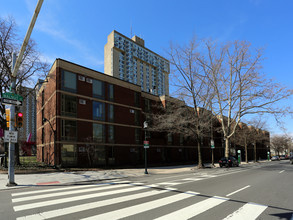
<box><xmin>83</xmin><ymin>193</ymin><xmax>194</xmax><ymax>220</ymax></box>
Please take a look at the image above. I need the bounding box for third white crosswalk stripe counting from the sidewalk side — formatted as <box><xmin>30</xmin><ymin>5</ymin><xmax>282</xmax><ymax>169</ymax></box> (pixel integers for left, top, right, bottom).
<box><xmin>13</xmin><ymin>185</ymin><xmax>148</xmax><ymax>212</ymax></box>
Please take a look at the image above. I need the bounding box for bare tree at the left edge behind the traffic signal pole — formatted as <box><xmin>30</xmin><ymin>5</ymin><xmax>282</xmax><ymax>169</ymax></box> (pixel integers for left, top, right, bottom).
<box><xmin>0</xmin><ymin>17</ymin><xmax>49</xmax><ymax>163</ymax></box>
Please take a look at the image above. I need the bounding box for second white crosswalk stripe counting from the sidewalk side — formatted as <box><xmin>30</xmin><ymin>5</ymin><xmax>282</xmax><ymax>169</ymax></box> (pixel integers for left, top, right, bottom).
<box><xmin>12</xmin><ymin>184</ymin><xmax>129</xmax><ymax>203</ymax></box>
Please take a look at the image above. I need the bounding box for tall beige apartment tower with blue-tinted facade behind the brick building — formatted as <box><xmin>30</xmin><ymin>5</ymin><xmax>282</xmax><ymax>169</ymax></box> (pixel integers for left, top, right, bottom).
<box><xmin>104</xmin><ymin>30</ymin><xmax>170</xmax><ymax>96</ymax></box>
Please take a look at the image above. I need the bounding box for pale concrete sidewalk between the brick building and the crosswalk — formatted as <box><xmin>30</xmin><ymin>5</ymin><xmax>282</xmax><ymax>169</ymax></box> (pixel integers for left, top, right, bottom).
<box><xmin>0</xmin><ymin>165</ymin><xmax>196</xmax><ymax>190</ymax></box>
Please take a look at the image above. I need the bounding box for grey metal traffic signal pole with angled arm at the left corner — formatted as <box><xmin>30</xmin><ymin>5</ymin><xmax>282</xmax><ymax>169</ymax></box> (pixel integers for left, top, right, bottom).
<box><xmin>7</xmin><ymin>0</ymin><xmax>44</xmax><ymax>186</ymax></box>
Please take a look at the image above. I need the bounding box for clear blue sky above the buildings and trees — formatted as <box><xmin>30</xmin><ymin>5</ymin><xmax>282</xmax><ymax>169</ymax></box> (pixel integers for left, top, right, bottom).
<box><xmin>0</xmin><ymin>0</ymin><xmax>293</xmax><ymax>133</ymax></box>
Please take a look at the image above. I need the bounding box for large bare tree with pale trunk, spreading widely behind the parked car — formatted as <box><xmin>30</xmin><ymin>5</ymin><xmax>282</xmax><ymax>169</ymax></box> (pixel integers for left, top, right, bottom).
<box><xmin>197</xmin><ymin>41</ymin><xmax>293</xmax><ymax>157</ymax></box>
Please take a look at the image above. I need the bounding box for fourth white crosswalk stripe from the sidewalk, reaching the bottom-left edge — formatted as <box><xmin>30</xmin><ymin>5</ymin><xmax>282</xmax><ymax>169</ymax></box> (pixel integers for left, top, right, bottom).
<box><xmin>17</xmin><ymin>190</ymin><xmax>168</xmax><ymax>220</ymax></box>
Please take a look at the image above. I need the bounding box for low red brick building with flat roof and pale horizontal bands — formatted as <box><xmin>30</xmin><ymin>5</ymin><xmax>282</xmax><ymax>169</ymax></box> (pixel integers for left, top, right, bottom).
<box><xmin>37</xmin><ymin>59</ymin><xmax>266</xmax><ymax>167</ymax></box>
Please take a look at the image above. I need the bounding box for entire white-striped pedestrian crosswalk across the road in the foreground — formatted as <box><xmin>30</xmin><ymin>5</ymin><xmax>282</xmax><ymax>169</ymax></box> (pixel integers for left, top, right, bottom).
<box><xmin>11</xmin><ymin>178</ymin><xmax>267</xmax><ymax>220</ymax></box>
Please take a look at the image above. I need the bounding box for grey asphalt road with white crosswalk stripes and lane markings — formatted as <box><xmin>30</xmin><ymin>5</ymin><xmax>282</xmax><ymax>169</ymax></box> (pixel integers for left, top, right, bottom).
<box><xmin>0</xmin><ymin>161</ymin><xmax>293</xmax><ymax>220</ymax></box>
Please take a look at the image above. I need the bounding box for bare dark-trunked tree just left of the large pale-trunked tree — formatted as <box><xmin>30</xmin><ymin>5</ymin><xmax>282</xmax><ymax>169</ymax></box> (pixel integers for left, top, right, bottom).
<box><xmin>153</xmin><ymin>40</ymin><xmax>212</xmax><ymax>168</ymax></box>
